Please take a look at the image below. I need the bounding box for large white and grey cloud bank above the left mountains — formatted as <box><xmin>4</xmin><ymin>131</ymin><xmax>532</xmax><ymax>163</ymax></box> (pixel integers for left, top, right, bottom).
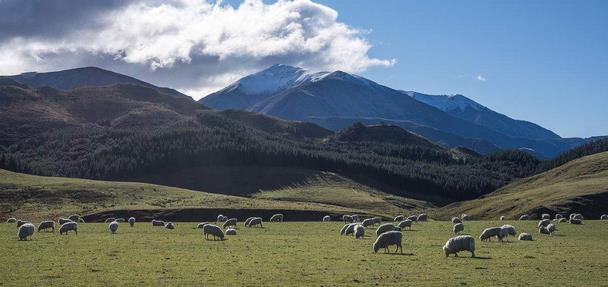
<box><xmin>0</xmin><ymin>0</ymin><xmax>394</xmax><ymax>98</ymax></box>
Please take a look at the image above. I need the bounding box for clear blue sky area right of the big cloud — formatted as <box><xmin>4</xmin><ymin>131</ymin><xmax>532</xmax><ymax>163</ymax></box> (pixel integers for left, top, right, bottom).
<box><xmin>319</xmin><ymin>0</ymin><xmax>608</xmax><ymax>137</ymax></box>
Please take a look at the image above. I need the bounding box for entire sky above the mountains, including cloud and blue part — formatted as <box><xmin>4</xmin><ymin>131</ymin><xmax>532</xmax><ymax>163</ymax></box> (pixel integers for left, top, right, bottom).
<box><xmin>0</xmin><ymin>0</ymin><xmax>608</xmax><ymax>137</ymax></box>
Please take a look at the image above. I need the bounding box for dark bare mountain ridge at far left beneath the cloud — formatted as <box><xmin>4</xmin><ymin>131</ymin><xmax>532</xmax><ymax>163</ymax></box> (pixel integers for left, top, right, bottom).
<box><xmin>0</xmin><ymin>67</ymin><xmax>188</xmax><ymax>97</ymax></box>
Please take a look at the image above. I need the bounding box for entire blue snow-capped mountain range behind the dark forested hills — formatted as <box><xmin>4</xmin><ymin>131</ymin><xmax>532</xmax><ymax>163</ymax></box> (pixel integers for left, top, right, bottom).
<box><xmin>199</xmin><ymin>65</ymin><xmax>585</xmax><ymax>158</ymax></box>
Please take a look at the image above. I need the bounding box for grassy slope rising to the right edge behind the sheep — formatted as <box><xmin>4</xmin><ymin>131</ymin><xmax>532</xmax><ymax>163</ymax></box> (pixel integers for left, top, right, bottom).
<box><xmin>437</xmin><ymin>152</ymin><xmax>608</xmax><ymax>219</ymax></box>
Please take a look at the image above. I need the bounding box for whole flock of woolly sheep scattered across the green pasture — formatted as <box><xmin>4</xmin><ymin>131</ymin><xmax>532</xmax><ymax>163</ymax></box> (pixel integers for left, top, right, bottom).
<box><xmin>7</xmin><ymin>213</ymin><xmax>608</xmax><ymax>257</ymax></box>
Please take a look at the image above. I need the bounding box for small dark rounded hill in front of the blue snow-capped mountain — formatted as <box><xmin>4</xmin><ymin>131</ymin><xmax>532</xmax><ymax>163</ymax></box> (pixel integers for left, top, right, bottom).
<box><xmin>335</xmin><ymin>123</ymin><xmax>436</xmax><ymax>147</ymax></box>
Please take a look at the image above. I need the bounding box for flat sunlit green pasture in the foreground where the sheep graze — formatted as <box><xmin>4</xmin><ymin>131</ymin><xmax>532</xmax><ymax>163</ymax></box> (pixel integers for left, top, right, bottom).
<box><xmin>0</xmin><ymin>221</ymin><xmax>608</xmax><ymax>286</ymax></box>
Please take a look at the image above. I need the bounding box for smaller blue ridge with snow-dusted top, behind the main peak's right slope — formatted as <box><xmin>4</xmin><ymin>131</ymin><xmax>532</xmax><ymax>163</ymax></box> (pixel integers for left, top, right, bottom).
<box><xmin>404</xmin><ymin>92</ymin><xmax>560</xmax><ymax>140</ymax></box>
